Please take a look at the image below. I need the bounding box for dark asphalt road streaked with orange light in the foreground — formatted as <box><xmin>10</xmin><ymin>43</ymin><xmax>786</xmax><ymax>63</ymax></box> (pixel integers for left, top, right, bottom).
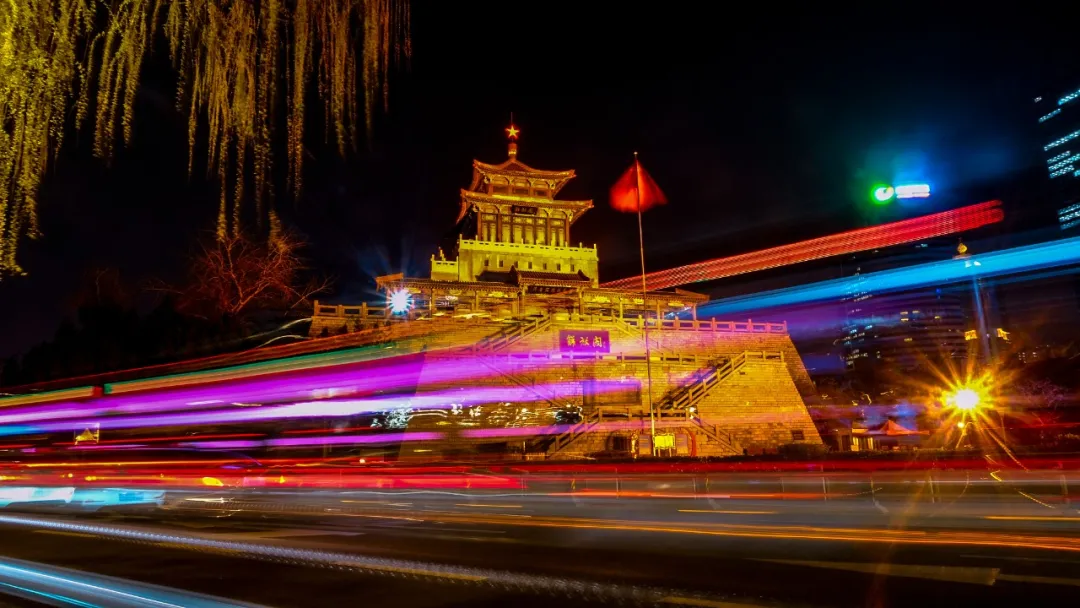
<box><xmin>0</xmin><ymin>494</ymin><xmax>1080</xmax><ymax>607</ymax></box>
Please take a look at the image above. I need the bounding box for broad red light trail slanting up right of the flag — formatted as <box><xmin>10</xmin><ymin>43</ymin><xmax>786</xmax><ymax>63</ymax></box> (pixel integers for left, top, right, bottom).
<box><xmin>600</xmin><ymin>201</ymin><xmax>1004</xmax><ymax>289</ymax></box>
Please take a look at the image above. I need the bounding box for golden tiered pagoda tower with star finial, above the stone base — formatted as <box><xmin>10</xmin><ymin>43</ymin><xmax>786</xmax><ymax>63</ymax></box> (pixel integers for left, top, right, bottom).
<box><xmin>376</xmin><ymin>124</ymin><xmax>708</xmax><ymax>317</ymax></box>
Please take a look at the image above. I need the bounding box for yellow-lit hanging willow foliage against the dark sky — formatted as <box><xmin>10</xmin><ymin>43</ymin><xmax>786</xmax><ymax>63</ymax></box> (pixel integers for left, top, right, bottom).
<box><xmin>0</xmin><ymin>0</ymin><xmax>410</xmax><ymax>278</ymax></box>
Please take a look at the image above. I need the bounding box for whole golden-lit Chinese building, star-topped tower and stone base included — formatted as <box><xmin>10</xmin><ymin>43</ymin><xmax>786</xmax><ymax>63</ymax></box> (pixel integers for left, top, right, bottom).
<box><xmin>311</xmin><ymin>125</ymin><xmax>821</xmax><ymax>458</ymax></box>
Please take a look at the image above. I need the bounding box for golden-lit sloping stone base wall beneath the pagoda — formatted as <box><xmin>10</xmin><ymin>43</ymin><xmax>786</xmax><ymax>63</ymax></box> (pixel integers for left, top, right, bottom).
<box><xmin>300</xmin><ymin>317</ymin><xmax>821</xmax><ymax>458</ymax></box>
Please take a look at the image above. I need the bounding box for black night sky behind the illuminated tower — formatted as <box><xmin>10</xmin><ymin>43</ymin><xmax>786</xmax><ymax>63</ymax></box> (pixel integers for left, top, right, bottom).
<box><xmin>0</xmin><ymin>7</ymin><xmax>1080</xmax><ymax>355</ymax></box>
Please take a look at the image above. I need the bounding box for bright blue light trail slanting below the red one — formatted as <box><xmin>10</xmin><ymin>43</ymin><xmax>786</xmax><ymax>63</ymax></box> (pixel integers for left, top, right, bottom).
<box><xmin>698</xmin><ymin>237</ymin><xmax>1080</xmax><ymax>316</ymax></box>
